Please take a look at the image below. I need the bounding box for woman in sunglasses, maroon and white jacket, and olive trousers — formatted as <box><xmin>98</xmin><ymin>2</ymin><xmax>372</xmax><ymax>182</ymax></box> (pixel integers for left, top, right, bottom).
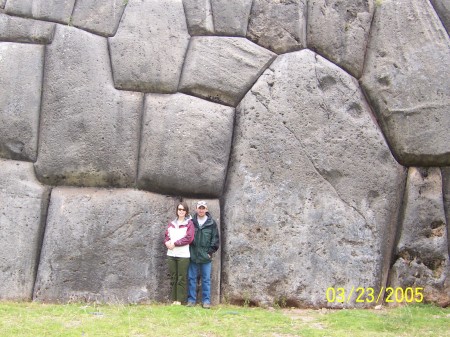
<box><xmin>164</xmin><ymin>202</ymin><xmax>195</xmax><ymax>305</ymax></box>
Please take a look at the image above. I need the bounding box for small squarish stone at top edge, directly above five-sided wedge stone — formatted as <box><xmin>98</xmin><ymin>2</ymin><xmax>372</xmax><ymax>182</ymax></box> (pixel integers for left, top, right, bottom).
<box><xmin>211</xmin><ymin>0</ymin><xmax>253</xmax><ymax>36</ymax></box>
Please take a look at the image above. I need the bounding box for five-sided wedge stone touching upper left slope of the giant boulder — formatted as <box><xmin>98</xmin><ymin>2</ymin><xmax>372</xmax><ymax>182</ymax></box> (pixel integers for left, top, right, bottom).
<box><xmin>179</xmin><ymin>37</ymin><xmax>276</xmax><ymax>106</ymax></box>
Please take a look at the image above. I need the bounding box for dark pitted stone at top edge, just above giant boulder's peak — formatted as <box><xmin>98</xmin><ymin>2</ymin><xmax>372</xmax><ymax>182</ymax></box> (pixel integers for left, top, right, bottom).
<box><xmin>247</xmin><ymin>0</ymin><xmax>307</xmax><ymax>54</ymax></box>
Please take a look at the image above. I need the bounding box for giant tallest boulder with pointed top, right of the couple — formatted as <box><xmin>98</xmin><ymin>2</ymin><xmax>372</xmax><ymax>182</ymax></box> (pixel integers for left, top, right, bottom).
<box><xmin>221</xmin><ymin>50</ymin><xmax>404</xmax><ymax>307</ymax></box>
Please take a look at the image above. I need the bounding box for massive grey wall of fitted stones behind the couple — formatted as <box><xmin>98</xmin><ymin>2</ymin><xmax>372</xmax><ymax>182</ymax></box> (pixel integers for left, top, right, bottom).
<box><xmin>0</xmin><ymin>0</ymin><xmax>450</xmax><ymax>307</ymax></box>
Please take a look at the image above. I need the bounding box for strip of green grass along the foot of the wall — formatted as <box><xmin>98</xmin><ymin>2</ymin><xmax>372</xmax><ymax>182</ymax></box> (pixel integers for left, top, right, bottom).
<box><xmin>0</xmin><ymin>302</ymin><xmax>450</xmax><ymax>337</ymax></box>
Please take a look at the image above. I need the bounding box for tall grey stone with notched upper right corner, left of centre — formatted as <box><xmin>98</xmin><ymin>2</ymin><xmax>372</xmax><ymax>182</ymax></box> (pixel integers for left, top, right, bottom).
<box><xmin>35</xmin><ymin>26</ymin><xmax>143</xmax><ymax>186</ymax></box>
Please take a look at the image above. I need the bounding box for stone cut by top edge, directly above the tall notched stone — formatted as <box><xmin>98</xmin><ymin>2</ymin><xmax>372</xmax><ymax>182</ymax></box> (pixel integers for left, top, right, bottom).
<box><xmin>72</xmin><ymin>0</ymin><xmax>126</xmax><ymax>36</ymax></box>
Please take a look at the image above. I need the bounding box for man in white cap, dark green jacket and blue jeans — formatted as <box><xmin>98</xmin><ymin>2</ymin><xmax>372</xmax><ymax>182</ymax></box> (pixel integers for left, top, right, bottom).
<box><xmin>187</xmin><ymin>200</ymin><xmax>219</xmax><ymax>309</ymax></box>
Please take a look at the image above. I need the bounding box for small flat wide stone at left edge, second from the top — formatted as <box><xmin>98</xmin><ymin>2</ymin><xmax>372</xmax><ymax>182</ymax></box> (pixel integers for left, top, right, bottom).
<box><xmin>0</xmin><ymin>13</ymin><xmax>55</xmax><ymax>44</ymax></box>
